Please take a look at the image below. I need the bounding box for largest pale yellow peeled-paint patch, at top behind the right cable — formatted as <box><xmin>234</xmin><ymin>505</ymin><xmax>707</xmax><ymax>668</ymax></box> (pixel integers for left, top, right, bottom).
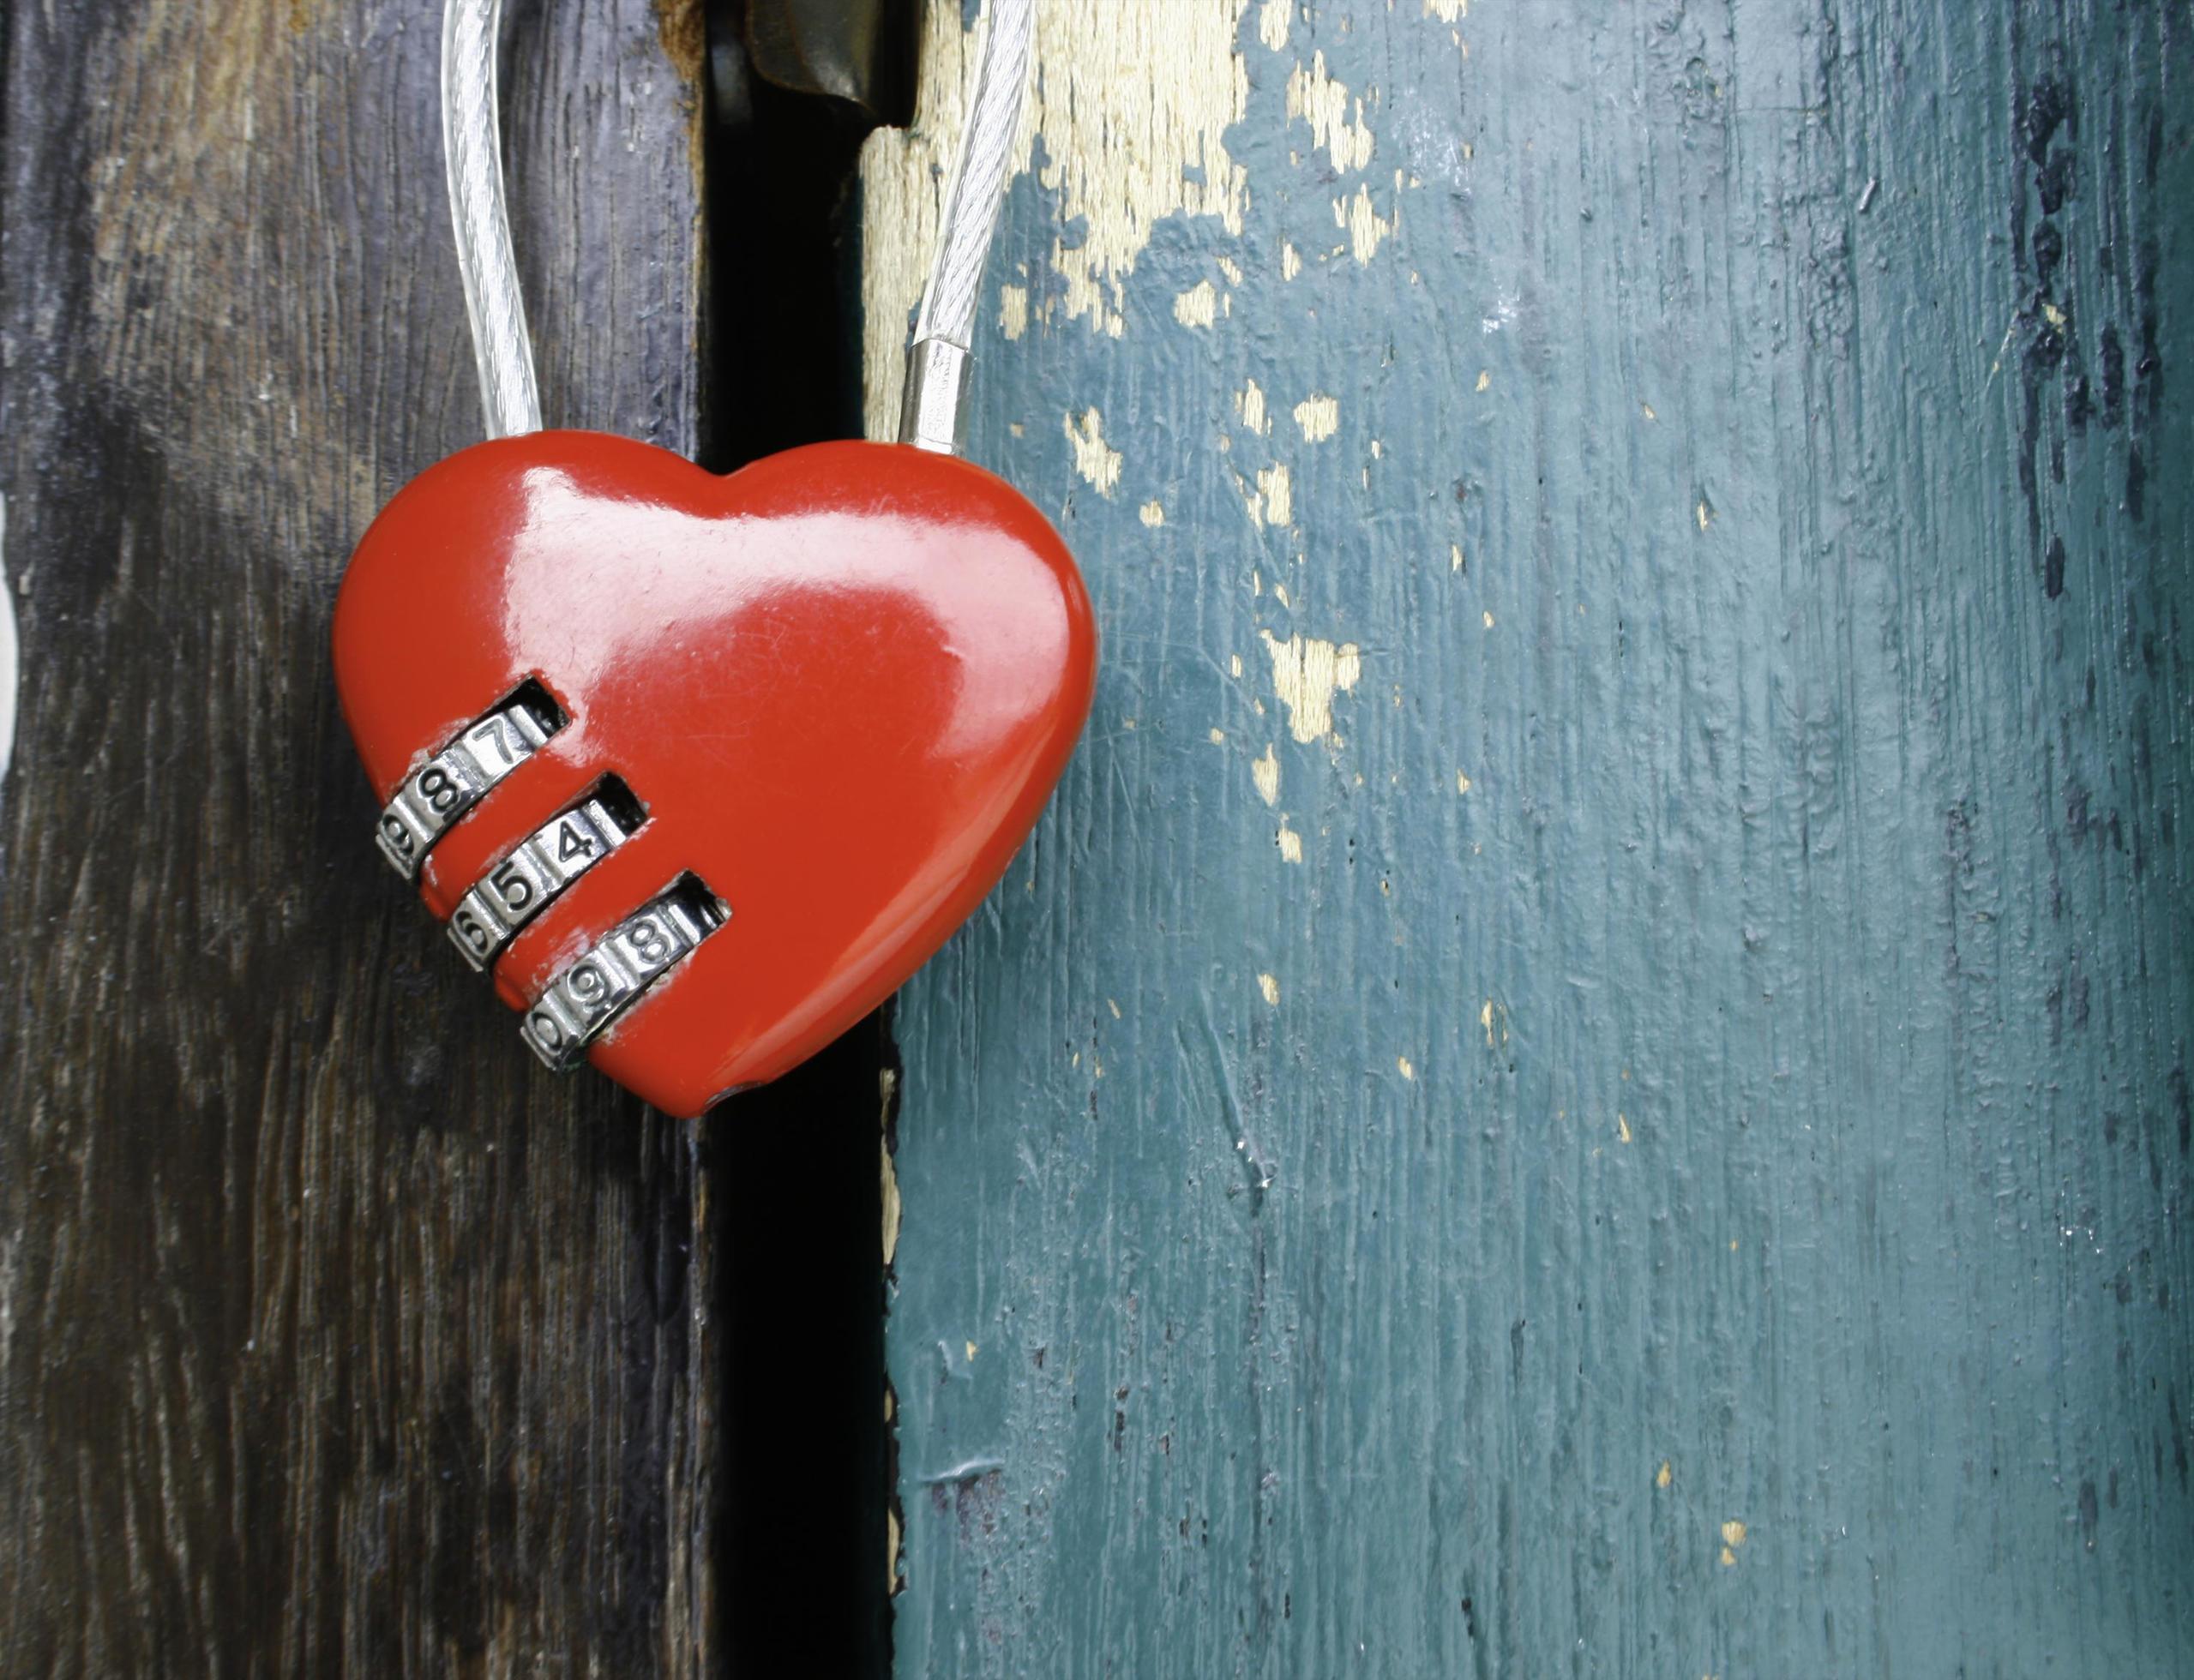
<box><xmin>860</xmin><ymin>0</ymin><xmax>1254</xmax><ymax>436</ymax></box>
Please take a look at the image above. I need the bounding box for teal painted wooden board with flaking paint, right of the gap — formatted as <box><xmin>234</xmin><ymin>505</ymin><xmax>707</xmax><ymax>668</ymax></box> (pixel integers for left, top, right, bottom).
<box><xmin>867</xmin><ymin>0</ymin><xmax>2194</xmax><ymax>1676</ymax></box>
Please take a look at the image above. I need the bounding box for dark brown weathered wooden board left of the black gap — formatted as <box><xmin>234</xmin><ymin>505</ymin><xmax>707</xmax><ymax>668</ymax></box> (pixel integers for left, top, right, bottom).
<box><xmin>0</xmin><ymin>0</ymin><xmax>718</xmax><ymax>1676</ymax></box>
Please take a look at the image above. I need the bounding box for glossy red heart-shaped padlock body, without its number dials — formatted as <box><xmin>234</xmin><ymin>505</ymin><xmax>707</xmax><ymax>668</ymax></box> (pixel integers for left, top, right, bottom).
<box><xmin>334</xmin><ymin>432</ymin><xmax>1097</xmax><ymax>1114</ymax></box>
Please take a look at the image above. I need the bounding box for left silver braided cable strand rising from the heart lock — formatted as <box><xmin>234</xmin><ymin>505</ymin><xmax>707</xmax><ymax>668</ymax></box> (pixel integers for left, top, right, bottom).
<box><xmin>441</xmin><ymin>0</ymin><xmax>542</xmax><ymax>436</ymax></box>
